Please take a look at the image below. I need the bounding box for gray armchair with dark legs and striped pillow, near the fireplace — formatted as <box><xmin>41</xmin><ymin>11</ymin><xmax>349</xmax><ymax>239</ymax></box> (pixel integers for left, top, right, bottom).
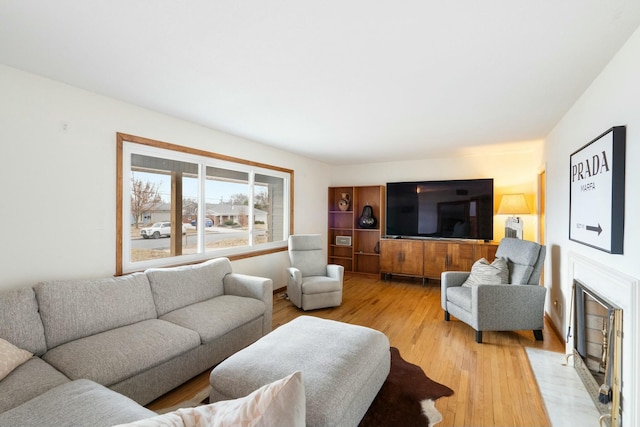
<box><xmin>441</xmin><ymin>238</ymin><xmax>547</xmax><ymax>343</ymax></box>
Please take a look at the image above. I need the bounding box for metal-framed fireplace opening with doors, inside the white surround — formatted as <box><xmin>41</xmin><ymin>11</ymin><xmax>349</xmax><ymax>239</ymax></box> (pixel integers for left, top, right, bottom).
<box><xmin>573</xmin><ymin>280</ymin><xmax>622</xmax><ymax>427</ymax></box>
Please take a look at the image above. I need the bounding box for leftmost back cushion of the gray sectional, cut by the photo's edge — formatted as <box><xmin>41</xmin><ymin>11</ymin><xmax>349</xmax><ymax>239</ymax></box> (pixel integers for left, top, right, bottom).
<box><xmin>0</xmin><ymin>288</ymin><xmax>47</xmax><ymax>356</ymax></box>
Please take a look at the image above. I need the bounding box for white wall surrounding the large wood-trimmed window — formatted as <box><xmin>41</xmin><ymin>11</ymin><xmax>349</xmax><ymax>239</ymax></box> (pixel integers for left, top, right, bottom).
<box><xmin>0</xmin><ymin>66</ymin><xmax>330</xmax><ymax>290</ymax></box>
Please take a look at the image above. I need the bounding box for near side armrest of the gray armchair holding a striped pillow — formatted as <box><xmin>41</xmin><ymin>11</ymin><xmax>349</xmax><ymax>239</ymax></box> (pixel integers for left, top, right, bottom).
<box><xmin>471</xmin><ymin>285</ymin><xmax>547</xmax><ymax>331</ymax></box>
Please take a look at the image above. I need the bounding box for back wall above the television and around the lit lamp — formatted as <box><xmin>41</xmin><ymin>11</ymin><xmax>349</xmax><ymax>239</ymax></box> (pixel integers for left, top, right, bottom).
<box><xmin>331</xmin><ymin>141</ymin><xmax>543</xmax><ymax>241</ymax></box>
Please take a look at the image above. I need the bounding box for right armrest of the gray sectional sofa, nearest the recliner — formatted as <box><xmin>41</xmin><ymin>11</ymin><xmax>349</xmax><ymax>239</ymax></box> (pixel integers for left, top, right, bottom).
<box><xmin>222</xmin><ymin>273</ymin><xmax>273</xmax><ymax>335</ymax></box>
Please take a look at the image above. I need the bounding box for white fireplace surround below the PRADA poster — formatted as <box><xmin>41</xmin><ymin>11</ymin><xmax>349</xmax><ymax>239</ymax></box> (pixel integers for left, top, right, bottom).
<box><xmin>564</xmin><ymin>252</ymin><xmax>640</xmax><ymax>426</ymax></box>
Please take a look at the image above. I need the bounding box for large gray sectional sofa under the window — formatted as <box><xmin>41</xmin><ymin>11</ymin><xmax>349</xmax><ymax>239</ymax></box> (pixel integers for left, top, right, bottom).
<box><xmin>0</xmin><ymin>258</ymin><xmax>273</xmax><ymax>426</ymax></box>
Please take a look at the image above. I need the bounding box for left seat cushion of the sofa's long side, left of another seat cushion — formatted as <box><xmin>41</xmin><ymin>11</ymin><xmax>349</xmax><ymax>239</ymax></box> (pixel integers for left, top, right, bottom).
<box><xmin>43</xmin><ymin>319</ymin><xmax>200</xmax><ymax>386</ymax></box>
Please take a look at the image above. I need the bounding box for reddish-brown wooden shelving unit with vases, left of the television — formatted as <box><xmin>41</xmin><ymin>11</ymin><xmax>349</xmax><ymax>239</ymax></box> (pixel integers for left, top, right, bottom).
<box><xmin>327</xmin><ymin>185</ymin><xmax>385</xmax><ymax>277</ymax></box>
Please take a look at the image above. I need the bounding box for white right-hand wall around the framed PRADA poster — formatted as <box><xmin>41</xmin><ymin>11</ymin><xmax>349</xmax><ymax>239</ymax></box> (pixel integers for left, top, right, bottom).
<box><xmin>544</xmin><ymin>26</ymin><xmax>640</xmax><ymax>425</ymax></box>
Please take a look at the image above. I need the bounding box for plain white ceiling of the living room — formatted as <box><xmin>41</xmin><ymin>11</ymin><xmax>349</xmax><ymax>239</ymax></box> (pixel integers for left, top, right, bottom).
<box><xmin>0</xmin><ymin>0</ymin><xmax>640</xmax><ymax>164</ymax></box>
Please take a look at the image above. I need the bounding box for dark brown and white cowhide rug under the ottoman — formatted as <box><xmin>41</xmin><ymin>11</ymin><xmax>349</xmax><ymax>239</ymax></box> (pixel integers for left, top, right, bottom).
<box><xmin>156</xmin><ymin>347</ymin><xmax>453</xmax><ymax>427</ymax></box>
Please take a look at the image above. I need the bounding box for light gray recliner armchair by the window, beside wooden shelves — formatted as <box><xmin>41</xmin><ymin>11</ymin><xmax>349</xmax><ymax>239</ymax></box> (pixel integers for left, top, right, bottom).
<box><xmin>287</xmin><ymin>234</ymin><xmax>344</xmax><ymax>311</ymax></box>
